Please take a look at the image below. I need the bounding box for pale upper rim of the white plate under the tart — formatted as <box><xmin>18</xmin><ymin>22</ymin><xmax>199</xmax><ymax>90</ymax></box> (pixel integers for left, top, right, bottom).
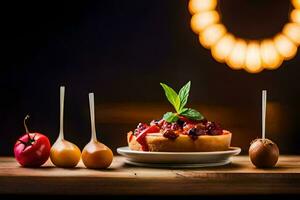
<box><xmin>117</xmin><ymin>146</ymin><xmax>242</xmax><ymax>155</ymax></box>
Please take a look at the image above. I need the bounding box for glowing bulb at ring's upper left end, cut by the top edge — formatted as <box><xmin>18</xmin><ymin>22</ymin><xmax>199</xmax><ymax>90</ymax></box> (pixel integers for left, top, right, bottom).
<box><xmin>189</xmin><ymin>0</ymin><xmax>217</xmax><ymax>14</ymax></box>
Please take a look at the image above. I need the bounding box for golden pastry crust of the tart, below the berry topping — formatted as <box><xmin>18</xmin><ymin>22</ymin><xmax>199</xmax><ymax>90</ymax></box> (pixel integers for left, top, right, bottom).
<box><xmin>127</xmin><ymin>130</ymin><xmax>232</xmax><ymax>152</ymax></box>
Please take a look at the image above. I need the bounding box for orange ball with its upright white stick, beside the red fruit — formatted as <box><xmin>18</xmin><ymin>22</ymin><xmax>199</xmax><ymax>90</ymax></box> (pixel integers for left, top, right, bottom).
<box><xmin>50</xmin><ymin>86</ymin><xmax>81</xmax><ymax>168</ymax></box>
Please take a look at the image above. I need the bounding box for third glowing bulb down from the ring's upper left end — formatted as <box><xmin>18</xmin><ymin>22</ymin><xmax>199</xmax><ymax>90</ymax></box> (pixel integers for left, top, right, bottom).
<box><xmin>199</xmin><ymin>24</ymin><xmax>226</xmax><ymax>48</ymax></box>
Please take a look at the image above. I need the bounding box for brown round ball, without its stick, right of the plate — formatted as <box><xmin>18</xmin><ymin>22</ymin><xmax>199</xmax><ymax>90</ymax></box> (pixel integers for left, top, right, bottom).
<box><xmin>249</xmin><ymin>139</ymin><xmax>279</xmax><ymax>168</ymax></box>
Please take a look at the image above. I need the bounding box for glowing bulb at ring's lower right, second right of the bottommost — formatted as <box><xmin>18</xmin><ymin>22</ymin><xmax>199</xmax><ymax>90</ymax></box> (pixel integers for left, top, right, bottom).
<box><xmin>274</xmin><ymin>34</ymin><xmax>297</xmax><ymax>60</ymax></box>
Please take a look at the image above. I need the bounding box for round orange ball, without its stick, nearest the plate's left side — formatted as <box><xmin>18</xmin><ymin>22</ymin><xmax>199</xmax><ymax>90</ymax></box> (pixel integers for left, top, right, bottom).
<box><xmin>81</xmin><ymin>141</ymin><xmax>113</xmax><ymax>169</ymax></box>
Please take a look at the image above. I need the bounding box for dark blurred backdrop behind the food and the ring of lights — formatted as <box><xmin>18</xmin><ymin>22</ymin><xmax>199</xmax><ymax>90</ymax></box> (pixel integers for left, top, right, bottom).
<box><xmin>0</xmin><ymin>0</ymin><xmax>300</xmax><ymax>156</ymax></box>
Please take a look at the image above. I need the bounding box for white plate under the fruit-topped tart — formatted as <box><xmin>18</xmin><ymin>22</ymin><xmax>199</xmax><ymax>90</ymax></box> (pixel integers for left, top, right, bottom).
<box><xmin>117</xmin><ymin>147</ymin><xmax>241</xmax><ymax>168</ymax></box>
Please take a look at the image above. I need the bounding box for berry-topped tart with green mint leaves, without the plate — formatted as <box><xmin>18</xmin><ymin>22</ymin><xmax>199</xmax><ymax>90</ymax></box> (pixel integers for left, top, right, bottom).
<box><xmin>127</xmin><ymin>81</ymin><xmax>232</xmax><ymax>152</ymax></box>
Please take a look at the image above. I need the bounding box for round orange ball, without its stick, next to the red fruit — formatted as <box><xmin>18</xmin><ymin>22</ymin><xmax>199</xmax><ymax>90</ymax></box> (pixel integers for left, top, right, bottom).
<box><xmin>50</xmin><ymin>139</ymin><xmax>81</xmax><ymax>168</ymax></box>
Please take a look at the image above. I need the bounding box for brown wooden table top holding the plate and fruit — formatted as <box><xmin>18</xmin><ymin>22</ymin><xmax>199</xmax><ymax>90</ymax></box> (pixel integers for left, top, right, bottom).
<box><xmin>0</xmin><ymin>156</ymin><xmax>300</xmax><ymax>195</ymax></box>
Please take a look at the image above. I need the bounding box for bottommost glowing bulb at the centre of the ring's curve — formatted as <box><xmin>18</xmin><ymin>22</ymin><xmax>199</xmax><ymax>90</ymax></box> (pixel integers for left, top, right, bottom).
<box><xmin>245</xmin><ymin>41</ymin><xmax>263</xmax><ymax>73</ymax></box>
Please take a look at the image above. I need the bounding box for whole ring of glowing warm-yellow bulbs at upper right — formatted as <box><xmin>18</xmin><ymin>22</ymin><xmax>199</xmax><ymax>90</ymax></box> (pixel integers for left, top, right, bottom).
<box><xmin>189</xmin><ymin>0</ymin><xmax>300</xmax><ymax>73</ymax></box>
